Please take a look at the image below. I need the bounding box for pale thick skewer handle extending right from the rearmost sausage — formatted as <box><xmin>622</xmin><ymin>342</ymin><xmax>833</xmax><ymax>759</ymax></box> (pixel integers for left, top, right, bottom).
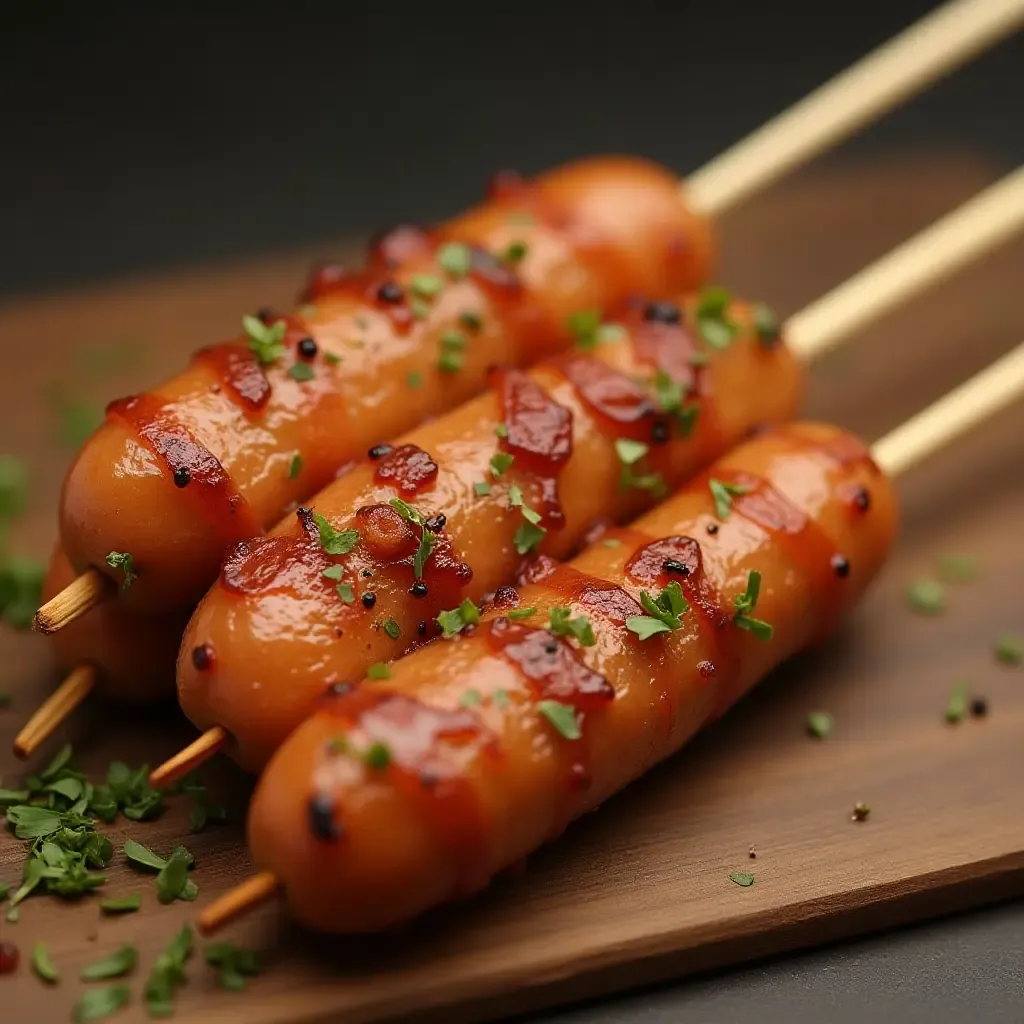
<box><xmin>683</xmin><ymin>0</ymin><xmax>1024</xmax><ymax>215</ymax></box>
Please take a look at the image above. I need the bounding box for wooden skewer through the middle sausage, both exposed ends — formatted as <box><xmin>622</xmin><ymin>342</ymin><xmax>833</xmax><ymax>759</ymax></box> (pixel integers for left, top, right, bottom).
<box><xmin>150</xmin><ymin>168</ymin><xmax>1024</xmax><ymax>788</ymax></box>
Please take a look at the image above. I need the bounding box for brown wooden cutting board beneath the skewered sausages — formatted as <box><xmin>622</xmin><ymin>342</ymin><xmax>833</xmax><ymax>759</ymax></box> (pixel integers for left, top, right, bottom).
<box><xmin>0</xmin><ymin>155</ymin><xmax>1024</xmax><ymax>1024</ymax></box>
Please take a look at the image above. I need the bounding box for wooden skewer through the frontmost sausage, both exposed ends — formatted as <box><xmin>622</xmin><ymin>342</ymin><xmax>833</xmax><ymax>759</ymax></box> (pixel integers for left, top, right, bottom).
<box><xmin>199</xmin><ymin>343</ymin><xmax>1024</xmax><ymax>935</ymax></box>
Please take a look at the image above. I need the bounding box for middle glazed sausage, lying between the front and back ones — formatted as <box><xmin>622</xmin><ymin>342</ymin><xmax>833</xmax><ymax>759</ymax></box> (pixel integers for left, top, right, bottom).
<box><xmin>178</xmin><ymin>289</ymin><xmax>803</xmax><ymax>771</ymax></box>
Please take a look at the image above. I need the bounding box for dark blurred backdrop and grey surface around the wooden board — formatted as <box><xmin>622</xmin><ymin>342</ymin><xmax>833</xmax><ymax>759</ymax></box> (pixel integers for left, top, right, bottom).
<box><xmin>0</xmin><ymin>0</ymin><xmax>1024</xmax><ymax>1024</ymax></box>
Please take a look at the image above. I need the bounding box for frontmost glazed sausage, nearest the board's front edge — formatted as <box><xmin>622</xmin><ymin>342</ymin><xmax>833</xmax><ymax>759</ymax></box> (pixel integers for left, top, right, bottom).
<box><xmin>248</xmin><ymin>424</ymin><xmax>896</xmax><ymax>932</ymax></box>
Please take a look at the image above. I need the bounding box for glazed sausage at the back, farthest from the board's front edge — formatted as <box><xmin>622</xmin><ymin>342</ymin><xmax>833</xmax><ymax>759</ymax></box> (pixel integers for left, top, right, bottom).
<box><xmin>60</xmin><ymin>158</ymin><xmax>712</xmax><ymax>613</ymax></box>
